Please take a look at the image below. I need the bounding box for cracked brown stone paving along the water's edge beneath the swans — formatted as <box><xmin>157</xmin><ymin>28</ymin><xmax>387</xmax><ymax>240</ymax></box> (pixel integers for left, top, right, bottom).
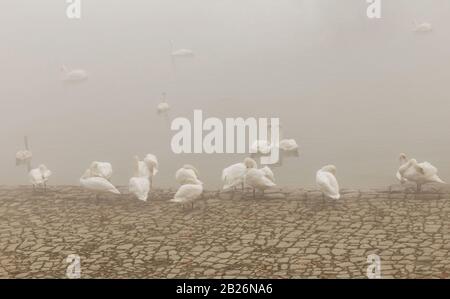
<box><xmin>0</xmin><ymin>185</ymin><xmax>450</xmax><ymax>278</ymax></box>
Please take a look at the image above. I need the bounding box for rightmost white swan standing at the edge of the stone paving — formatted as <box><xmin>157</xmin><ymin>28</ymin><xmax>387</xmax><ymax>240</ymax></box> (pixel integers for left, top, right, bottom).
<box><xmin>398</xmin><ymin>156</ymin><xmax>445</xmax><ymax>192</ymax></box>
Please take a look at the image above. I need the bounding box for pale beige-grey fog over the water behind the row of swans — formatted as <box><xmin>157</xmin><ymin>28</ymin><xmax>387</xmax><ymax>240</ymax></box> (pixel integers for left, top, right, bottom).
<box><xmin>0</xmin><ymin>0</ymin><xmax>450</xmax><ymax>189</ymax></box>
